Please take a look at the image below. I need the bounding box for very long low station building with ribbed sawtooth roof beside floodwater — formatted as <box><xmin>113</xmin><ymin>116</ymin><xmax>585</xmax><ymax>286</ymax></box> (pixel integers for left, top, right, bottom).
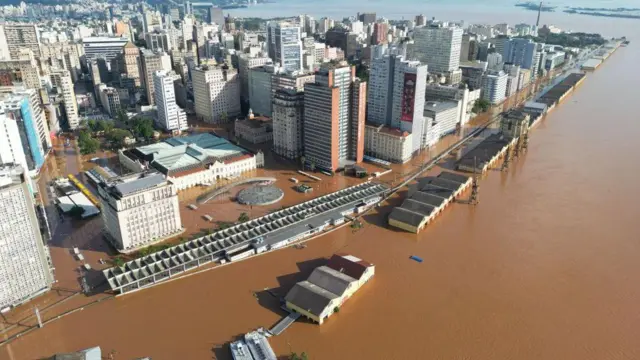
<box><xmin>103</xmin><ymin>182</ymin><xmax>388</xmax><ymax>293</ymax></box>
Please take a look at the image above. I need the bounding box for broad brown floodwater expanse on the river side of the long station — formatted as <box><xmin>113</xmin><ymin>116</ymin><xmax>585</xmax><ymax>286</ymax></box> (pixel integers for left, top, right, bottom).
<box><xmin>0</xmin><ymin>16</ymin><xmax>640</xmax><ymax>360</ymax></box>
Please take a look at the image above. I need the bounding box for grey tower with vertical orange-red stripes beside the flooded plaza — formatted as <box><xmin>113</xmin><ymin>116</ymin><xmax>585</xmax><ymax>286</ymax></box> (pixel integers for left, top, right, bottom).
<box><xmin>303</xmin><ymin>62</ymin><xmax>367</xmax><ymax>171</ymax></box>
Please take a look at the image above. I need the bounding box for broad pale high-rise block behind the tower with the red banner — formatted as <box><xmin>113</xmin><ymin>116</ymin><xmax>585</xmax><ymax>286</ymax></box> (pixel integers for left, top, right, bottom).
<box><xmin>413</xmin><ymin>26</ymin><xmax>462</xmax><ymax>73</ymax></box>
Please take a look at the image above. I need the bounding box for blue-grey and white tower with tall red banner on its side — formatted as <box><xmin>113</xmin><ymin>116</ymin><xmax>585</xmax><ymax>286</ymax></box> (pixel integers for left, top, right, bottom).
<box><xmin>367</xmin><ymin>55</ymin><xmax>427</xmax><ymax>150</ymax></box>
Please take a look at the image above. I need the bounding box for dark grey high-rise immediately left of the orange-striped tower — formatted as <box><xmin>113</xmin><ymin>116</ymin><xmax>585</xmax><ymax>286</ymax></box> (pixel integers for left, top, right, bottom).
<box><xmin>272</xmin><ymin>89</ymin><xmax>304</xmax><ymax>159</ymax></box>
